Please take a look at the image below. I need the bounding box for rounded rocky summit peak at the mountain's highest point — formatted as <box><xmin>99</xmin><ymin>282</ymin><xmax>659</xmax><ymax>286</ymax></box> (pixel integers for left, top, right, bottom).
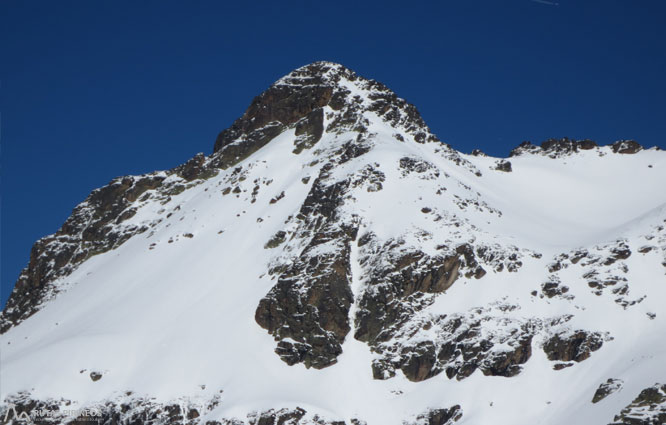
<box><xmin>213</xmin><ymin>62</ymin><xmax>438</xmax><ymax>157</ymax></box>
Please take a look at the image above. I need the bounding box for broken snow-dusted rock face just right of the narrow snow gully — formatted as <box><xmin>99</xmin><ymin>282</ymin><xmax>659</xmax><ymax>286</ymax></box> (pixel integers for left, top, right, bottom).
<box><xmin>344</xmin><ymin>233</ymin><xmax>533</xmax><ymax>381</ymax></box>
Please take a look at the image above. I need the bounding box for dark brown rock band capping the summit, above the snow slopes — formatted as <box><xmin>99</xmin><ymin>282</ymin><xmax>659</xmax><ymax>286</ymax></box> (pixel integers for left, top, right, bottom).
<box><xmin>211</xmin><ymin>62</ymin><xmax>436</xmax><ymax>168</ymax></box>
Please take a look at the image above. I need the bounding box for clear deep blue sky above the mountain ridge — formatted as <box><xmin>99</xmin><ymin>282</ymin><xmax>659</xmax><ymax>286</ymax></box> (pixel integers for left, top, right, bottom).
<box><xmin>0</xmin><ymin>0</ymin><xmax>666</xmax><ymax>305</ymax></box>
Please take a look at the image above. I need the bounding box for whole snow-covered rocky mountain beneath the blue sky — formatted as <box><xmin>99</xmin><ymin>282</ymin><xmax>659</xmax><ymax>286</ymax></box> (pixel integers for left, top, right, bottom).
<box><xmin>0</xmin><ymin>62</ymin><xmax>666</xmax><ymax>425</ymax></box>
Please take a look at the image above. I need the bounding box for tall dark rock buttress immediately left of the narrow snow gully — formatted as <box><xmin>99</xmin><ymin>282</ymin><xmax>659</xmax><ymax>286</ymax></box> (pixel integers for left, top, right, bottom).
<box><xmin>255</xmin><ymin>171</ymin><xmax>357</xmax><ymax>368</ymax></box>
